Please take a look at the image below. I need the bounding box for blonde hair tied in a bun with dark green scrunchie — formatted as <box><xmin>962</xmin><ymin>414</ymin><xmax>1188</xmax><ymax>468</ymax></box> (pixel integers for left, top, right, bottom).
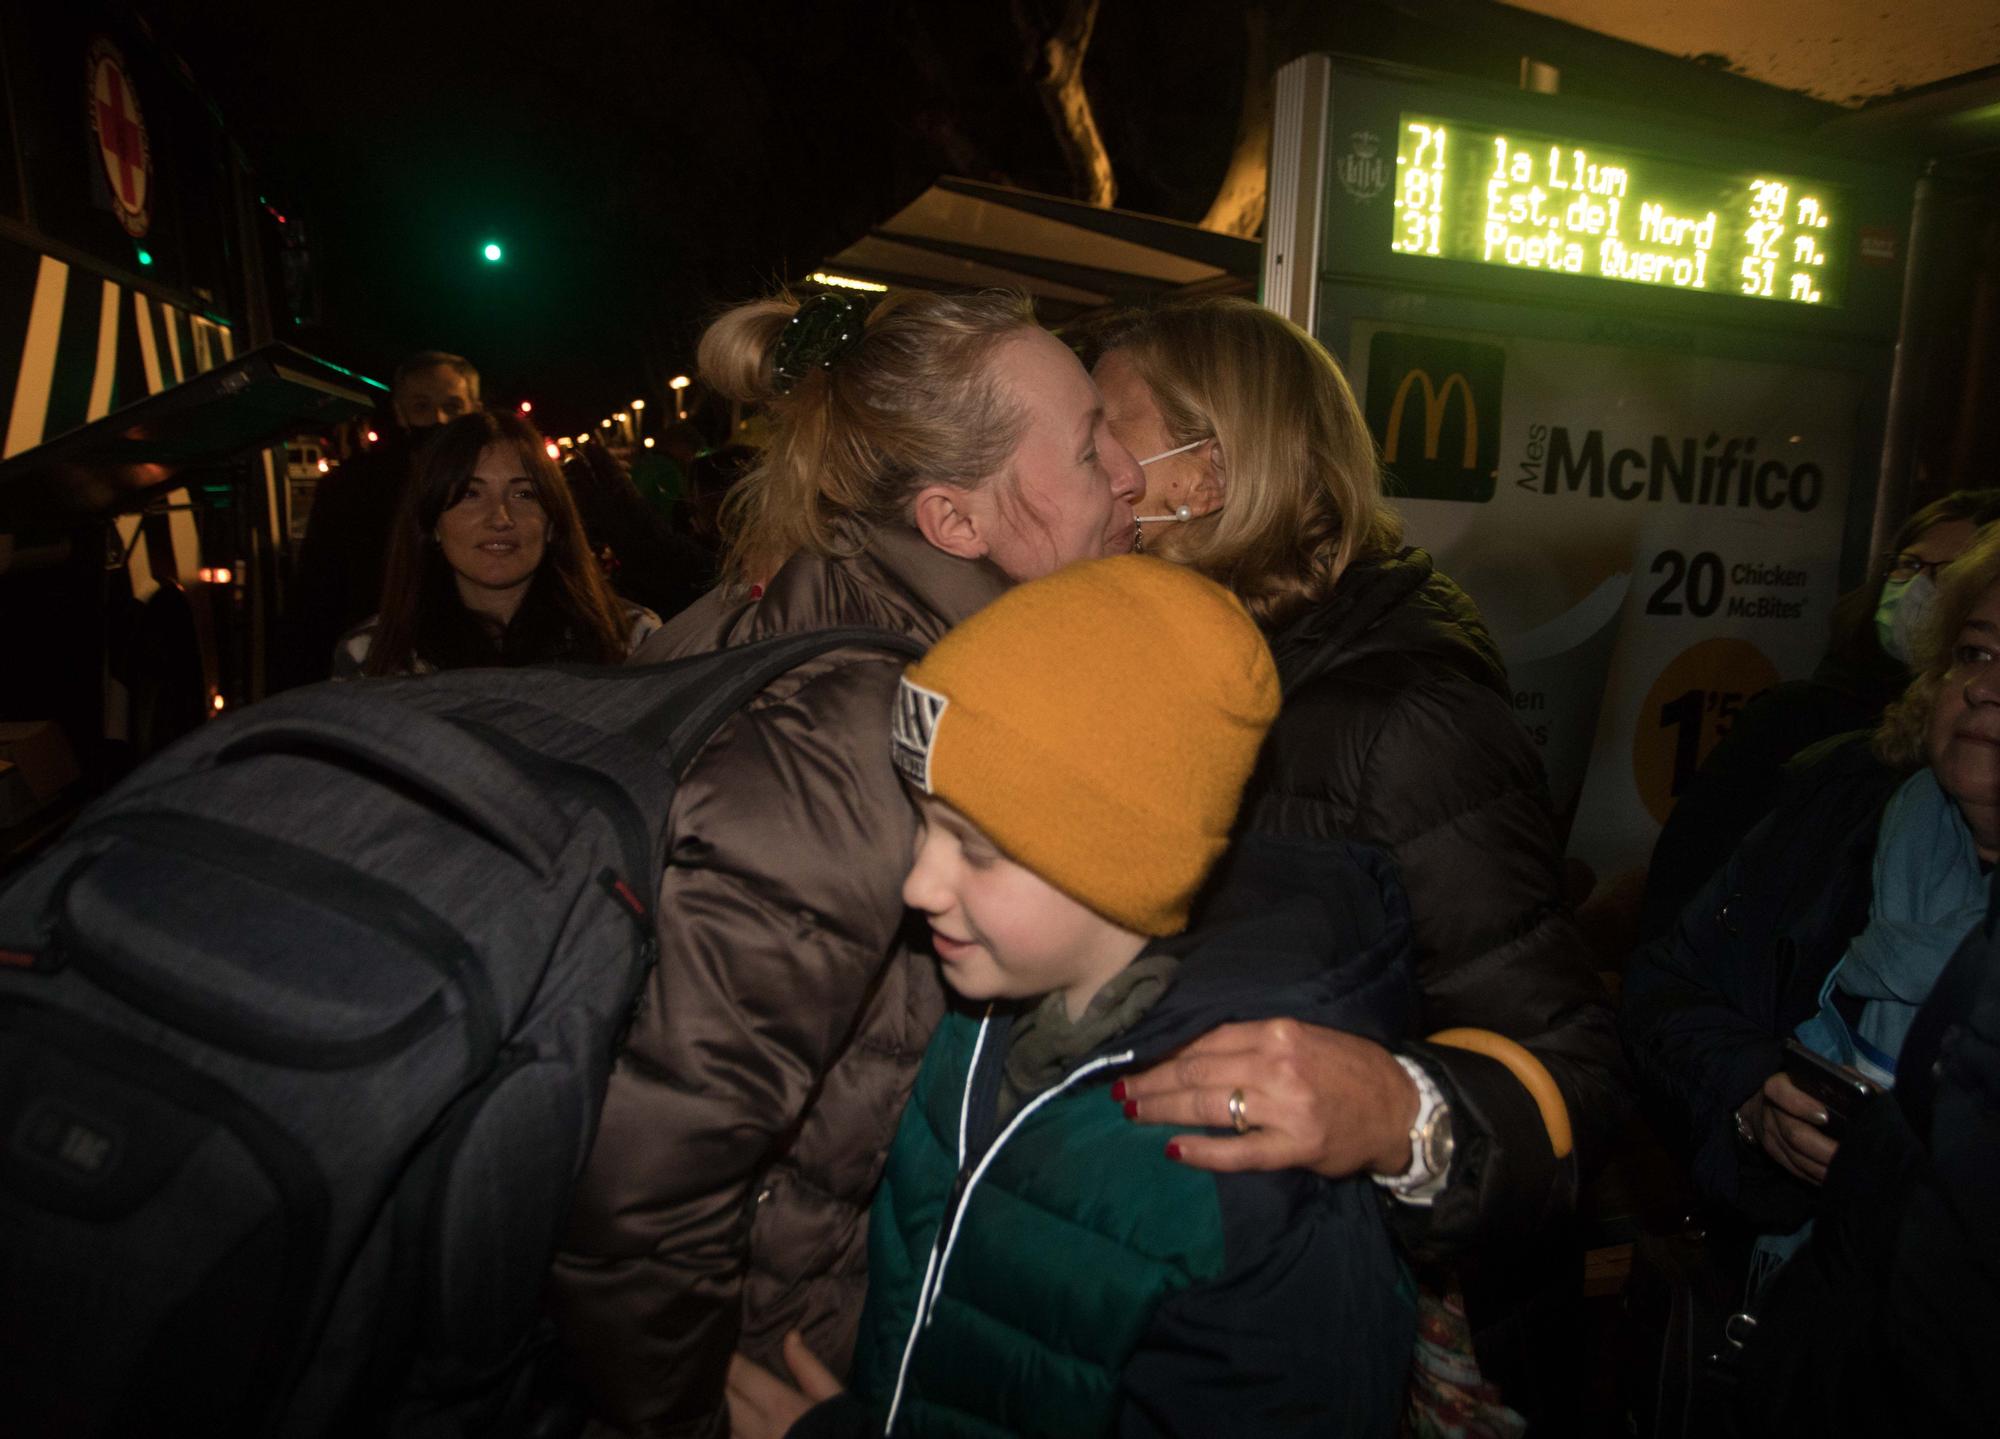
<box><xmin>698</xmin><ymin>290</ymin><xmax>1038</xmax><ymax>584</ymax></box>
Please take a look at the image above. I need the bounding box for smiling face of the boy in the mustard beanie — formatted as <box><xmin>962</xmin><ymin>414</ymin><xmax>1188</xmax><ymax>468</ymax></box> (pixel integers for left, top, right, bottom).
<box><xmin>902</xmin><ymin>795</ymin><xmax>1146</xmax><ymax>1019</ymax></box>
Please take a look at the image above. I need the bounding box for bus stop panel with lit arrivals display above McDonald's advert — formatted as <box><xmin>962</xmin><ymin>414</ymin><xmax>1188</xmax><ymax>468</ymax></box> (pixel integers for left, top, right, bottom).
<box><xmin>1264</xmin><ymin>56</ymin><xmax>1916</xmax><ymax>877</ymax></box>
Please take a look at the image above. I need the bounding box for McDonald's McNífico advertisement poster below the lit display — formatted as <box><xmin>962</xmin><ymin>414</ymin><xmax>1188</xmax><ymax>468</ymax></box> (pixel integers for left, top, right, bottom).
<box><xmin>1348</xmin><ymin>320</ymin><xmax>1864</xmax><ymax>879</ymax></box>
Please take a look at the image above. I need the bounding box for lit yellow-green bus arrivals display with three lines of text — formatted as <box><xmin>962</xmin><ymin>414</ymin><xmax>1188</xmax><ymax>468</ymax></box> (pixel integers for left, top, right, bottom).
<box><xmin>1390</xmin><ymin>114</ymin><xmax>1848</xmax><ymax>306</ymax></box>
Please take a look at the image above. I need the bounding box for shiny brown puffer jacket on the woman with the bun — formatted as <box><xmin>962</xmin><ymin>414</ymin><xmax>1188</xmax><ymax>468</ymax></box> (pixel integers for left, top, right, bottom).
<box><xmin>552</xmin><ymin>526</ymin><xmax>1006</xmax><ymax>1437</ymax></box>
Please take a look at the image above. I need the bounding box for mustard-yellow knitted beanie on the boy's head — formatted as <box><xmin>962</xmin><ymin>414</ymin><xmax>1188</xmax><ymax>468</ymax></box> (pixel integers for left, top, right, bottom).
<box><xmin>894</xmin><ymin>556</ymin><xmax>1278</xmax><ymax>935</ymax></box>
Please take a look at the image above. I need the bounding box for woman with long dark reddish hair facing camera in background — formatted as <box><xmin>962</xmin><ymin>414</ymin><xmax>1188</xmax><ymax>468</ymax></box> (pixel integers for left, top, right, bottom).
<box><xmin>334</xmin><ymin>410</ymin><xmax>660</xmax><ymax>680</ymax></box>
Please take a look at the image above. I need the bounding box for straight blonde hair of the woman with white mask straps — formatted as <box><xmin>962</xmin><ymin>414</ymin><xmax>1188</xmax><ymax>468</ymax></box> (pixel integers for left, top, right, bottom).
<box><xmin>1092</xmin><ymin>298</ymin><xmax>1402</xmax><ymax>630</ymax></box>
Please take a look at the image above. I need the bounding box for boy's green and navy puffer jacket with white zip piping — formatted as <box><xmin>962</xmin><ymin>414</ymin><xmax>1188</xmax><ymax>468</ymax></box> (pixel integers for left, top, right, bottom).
<box><xmin>794</xmin><ymin>839</ymin><xmax>1416</xmax><ymax>1439</ymax></box>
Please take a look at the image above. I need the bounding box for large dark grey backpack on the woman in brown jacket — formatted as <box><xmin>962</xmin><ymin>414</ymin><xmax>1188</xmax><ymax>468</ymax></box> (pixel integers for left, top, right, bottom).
<box><xmin>0</xmin><ymin>630</ymin><xmax>920</xmax><ymax>1439</ymax></box>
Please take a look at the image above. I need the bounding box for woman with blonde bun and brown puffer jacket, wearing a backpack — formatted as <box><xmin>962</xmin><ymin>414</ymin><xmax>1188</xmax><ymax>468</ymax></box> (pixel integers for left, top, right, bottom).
<box><xmin>552</xmin><ymin>292</ymin><xmax>1142</xmax><ymax>1435</ymax></box>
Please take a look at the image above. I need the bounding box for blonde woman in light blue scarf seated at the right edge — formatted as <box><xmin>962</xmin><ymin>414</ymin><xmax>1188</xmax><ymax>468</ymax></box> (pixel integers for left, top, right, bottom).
<box><xmin>1622</xmin><ymin>528</ymin><xmax>2000</xmax><ymax>1295</ymax></box>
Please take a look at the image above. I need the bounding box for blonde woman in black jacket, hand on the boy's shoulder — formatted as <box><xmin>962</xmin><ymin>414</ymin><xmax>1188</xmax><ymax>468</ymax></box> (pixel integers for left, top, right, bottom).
<box><xmin>1094</xmin><ymin>300</ymin><xmax>1626</xmax><ymax>1423</ymax></box>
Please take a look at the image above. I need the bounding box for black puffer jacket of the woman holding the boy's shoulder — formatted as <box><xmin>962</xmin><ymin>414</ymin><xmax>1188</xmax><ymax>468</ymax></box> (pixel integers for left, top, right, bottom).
<box><xmin>1244</xmin><ymin>550</ymin><xmax>1628</xmax><ymax>1401</ymax></box>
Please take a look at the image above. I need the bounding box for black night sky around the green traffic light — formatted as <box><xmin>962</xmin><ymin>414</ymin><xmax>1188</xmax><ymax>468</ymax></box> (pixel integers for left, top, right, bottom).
<box><xmin>144</xmin><ymin>0</ymin><xmax>1244</xmax><ymax>428</ymax></box>
